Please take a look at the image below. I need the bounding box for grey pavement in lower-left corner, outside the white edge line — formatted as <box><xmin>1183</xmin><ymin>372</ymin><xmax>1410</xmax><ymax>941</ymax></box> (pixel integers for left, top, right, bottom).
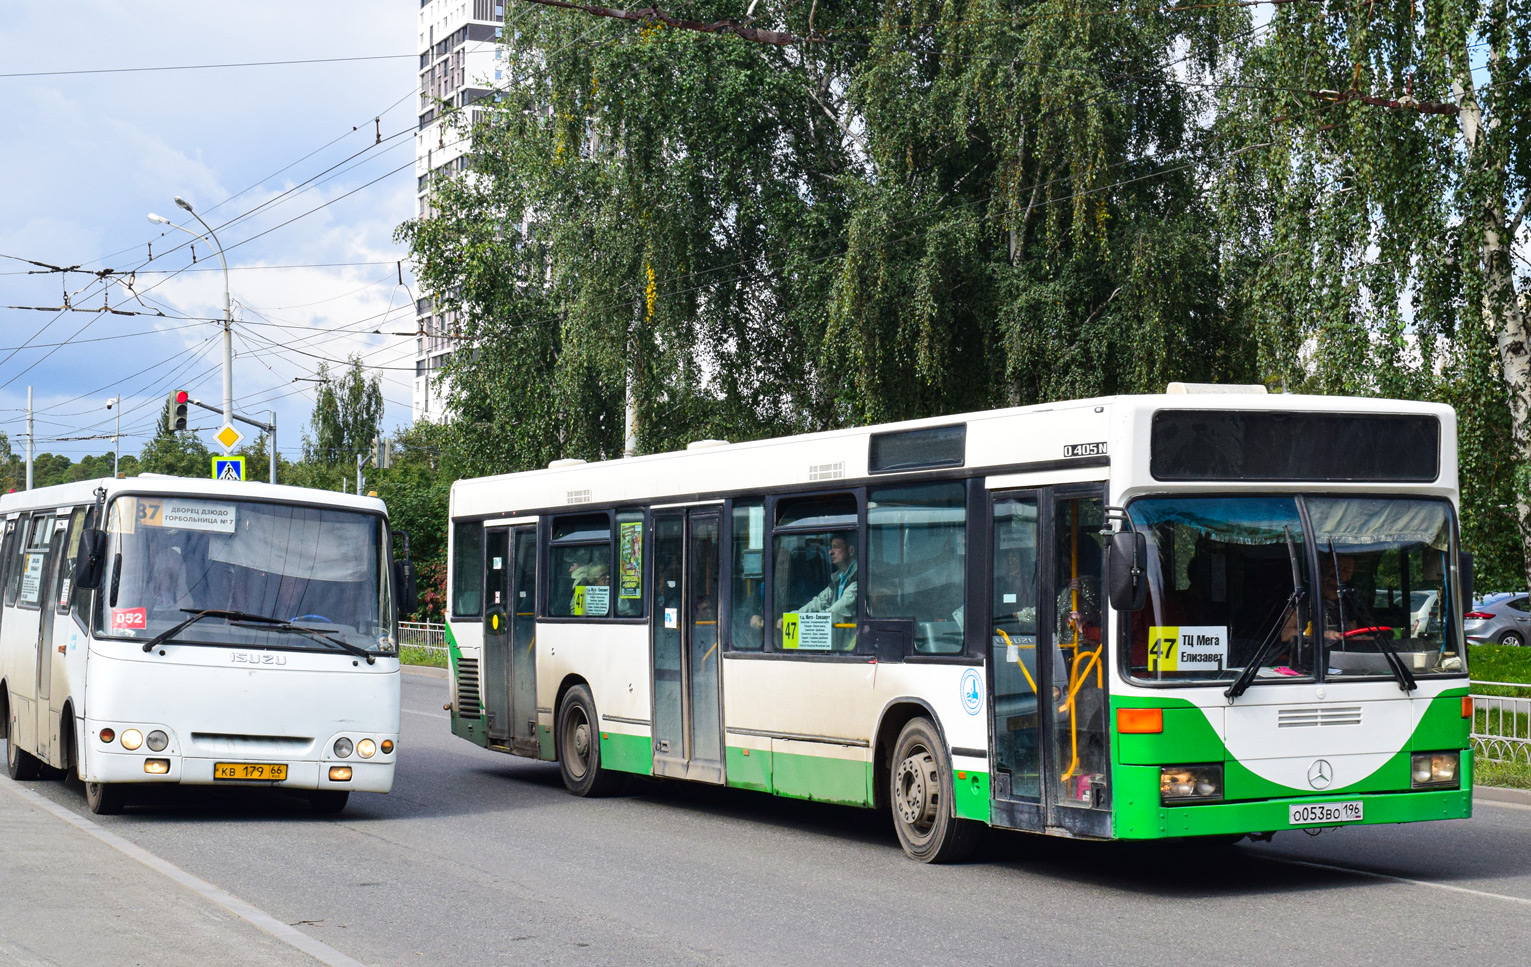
<box><xmin>0</xmin><ymin>776</ymin><xmax>329</xmax><ymax>967</ymax></box>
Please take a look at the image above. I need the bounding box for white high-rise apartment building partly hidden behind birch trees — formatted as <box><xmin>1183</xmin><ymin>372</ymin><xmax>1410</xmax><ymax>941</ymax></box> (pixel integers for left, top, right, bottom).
<box><xmin>412</xmin><ymin>0</ymin><xmax>507</xmax><ymax>419</ymax></box>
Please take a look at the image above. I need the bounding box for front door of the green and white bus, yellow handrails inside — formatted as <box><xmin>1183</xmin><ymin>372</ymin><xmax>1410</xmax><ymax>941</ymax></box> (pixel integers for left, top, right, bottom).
<box><xmin>989</xmin><ymin>487</ymin><xmax>1110</xmax><ymax>837</ymax></box>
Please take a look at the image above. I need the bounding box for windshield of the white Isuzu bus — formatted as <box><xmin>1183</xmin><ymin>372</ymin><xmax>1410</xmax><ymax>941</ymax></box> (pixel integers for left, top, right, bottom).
<box><xmin>95</xmin><ymin>494</ymin><xmax>395</xmax><ymax>653</ymax></box>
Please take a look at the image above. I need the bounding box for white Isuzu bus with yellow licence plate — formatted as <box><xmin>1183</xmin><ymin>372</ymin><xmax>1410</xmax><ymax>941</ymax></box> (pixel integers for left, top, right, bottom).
<box><xmin>0</xmin><ymin>474</ymin><xmax>413</xmax><ymax>812</ymax></box>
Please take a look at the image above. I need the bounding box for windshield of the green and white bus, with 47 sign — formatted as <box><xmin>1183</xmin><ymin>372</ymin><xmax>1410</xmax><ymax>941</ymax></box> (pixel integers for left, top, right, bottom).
<box><xmin>1128</xmin><ymin>496</ymin><xmax>1464</xmax><ymax>684</ymax></box>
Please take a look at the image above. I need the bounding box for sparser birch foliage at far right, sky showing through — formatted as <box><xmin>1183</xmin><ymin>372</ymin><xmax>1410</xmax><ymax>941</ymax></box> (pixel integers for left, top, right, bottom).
<box><xmin>1214</xmin><ymin>0</ymin><xmax>1531</xmax><ymax>588</ymax></box>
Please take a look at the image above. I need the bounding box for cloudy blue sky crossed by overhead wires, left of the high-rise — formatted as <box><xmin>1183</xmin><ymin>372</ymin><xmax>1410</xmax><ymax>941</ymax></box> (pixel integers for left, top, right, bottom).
<box><xmin>0</xmin><ymin>0</ymin><xmax>419</xmax><ymax>459</ymax></box>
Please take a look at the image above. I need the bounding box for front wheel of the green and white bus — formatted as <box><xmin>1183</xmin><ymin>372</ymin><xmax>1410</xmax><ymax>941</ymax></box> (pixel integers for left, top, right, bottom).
<box><xmin>888</xmin><ymin>718</ymin><xmax>983</xmax><ymax>863</ymax></box>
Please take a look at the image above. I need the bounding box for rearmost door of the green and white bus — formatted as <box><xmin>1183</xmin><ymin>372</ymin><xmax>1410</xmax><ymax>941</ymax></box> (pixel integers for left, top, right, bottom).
<box><xmin>481</xmin><ymin>526</ymin><xmax>539</xmax><ymax>756</ymax></box>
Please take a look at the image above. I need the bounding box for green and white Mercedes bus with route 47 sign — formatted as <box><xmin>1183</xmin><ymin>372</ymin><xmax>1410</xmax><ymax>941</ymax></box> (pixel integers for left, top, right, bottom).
<box><xmin>447</xmin><ymin>386</ymin><xmax>1471</xmax><ymax>861</ymax></box>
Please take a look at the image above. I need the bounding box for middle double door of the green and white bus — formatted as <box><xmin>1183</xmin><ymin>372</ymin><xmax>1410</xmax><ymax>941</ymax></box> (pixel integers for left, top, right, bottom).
<box><xmin>651</xmin><ymin>508</ymin><xmax>723</xmax><ymax>783</ymax></box>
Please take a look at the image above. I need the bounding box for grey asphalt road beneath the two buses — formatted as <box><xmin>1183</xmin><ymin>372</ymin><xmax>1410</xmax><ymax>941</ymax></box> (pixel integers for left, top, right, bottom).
<box><xmin>0</xmin><ymin>675</ymin><xmax>1531</xmax><ymax>967</ymax></box>
